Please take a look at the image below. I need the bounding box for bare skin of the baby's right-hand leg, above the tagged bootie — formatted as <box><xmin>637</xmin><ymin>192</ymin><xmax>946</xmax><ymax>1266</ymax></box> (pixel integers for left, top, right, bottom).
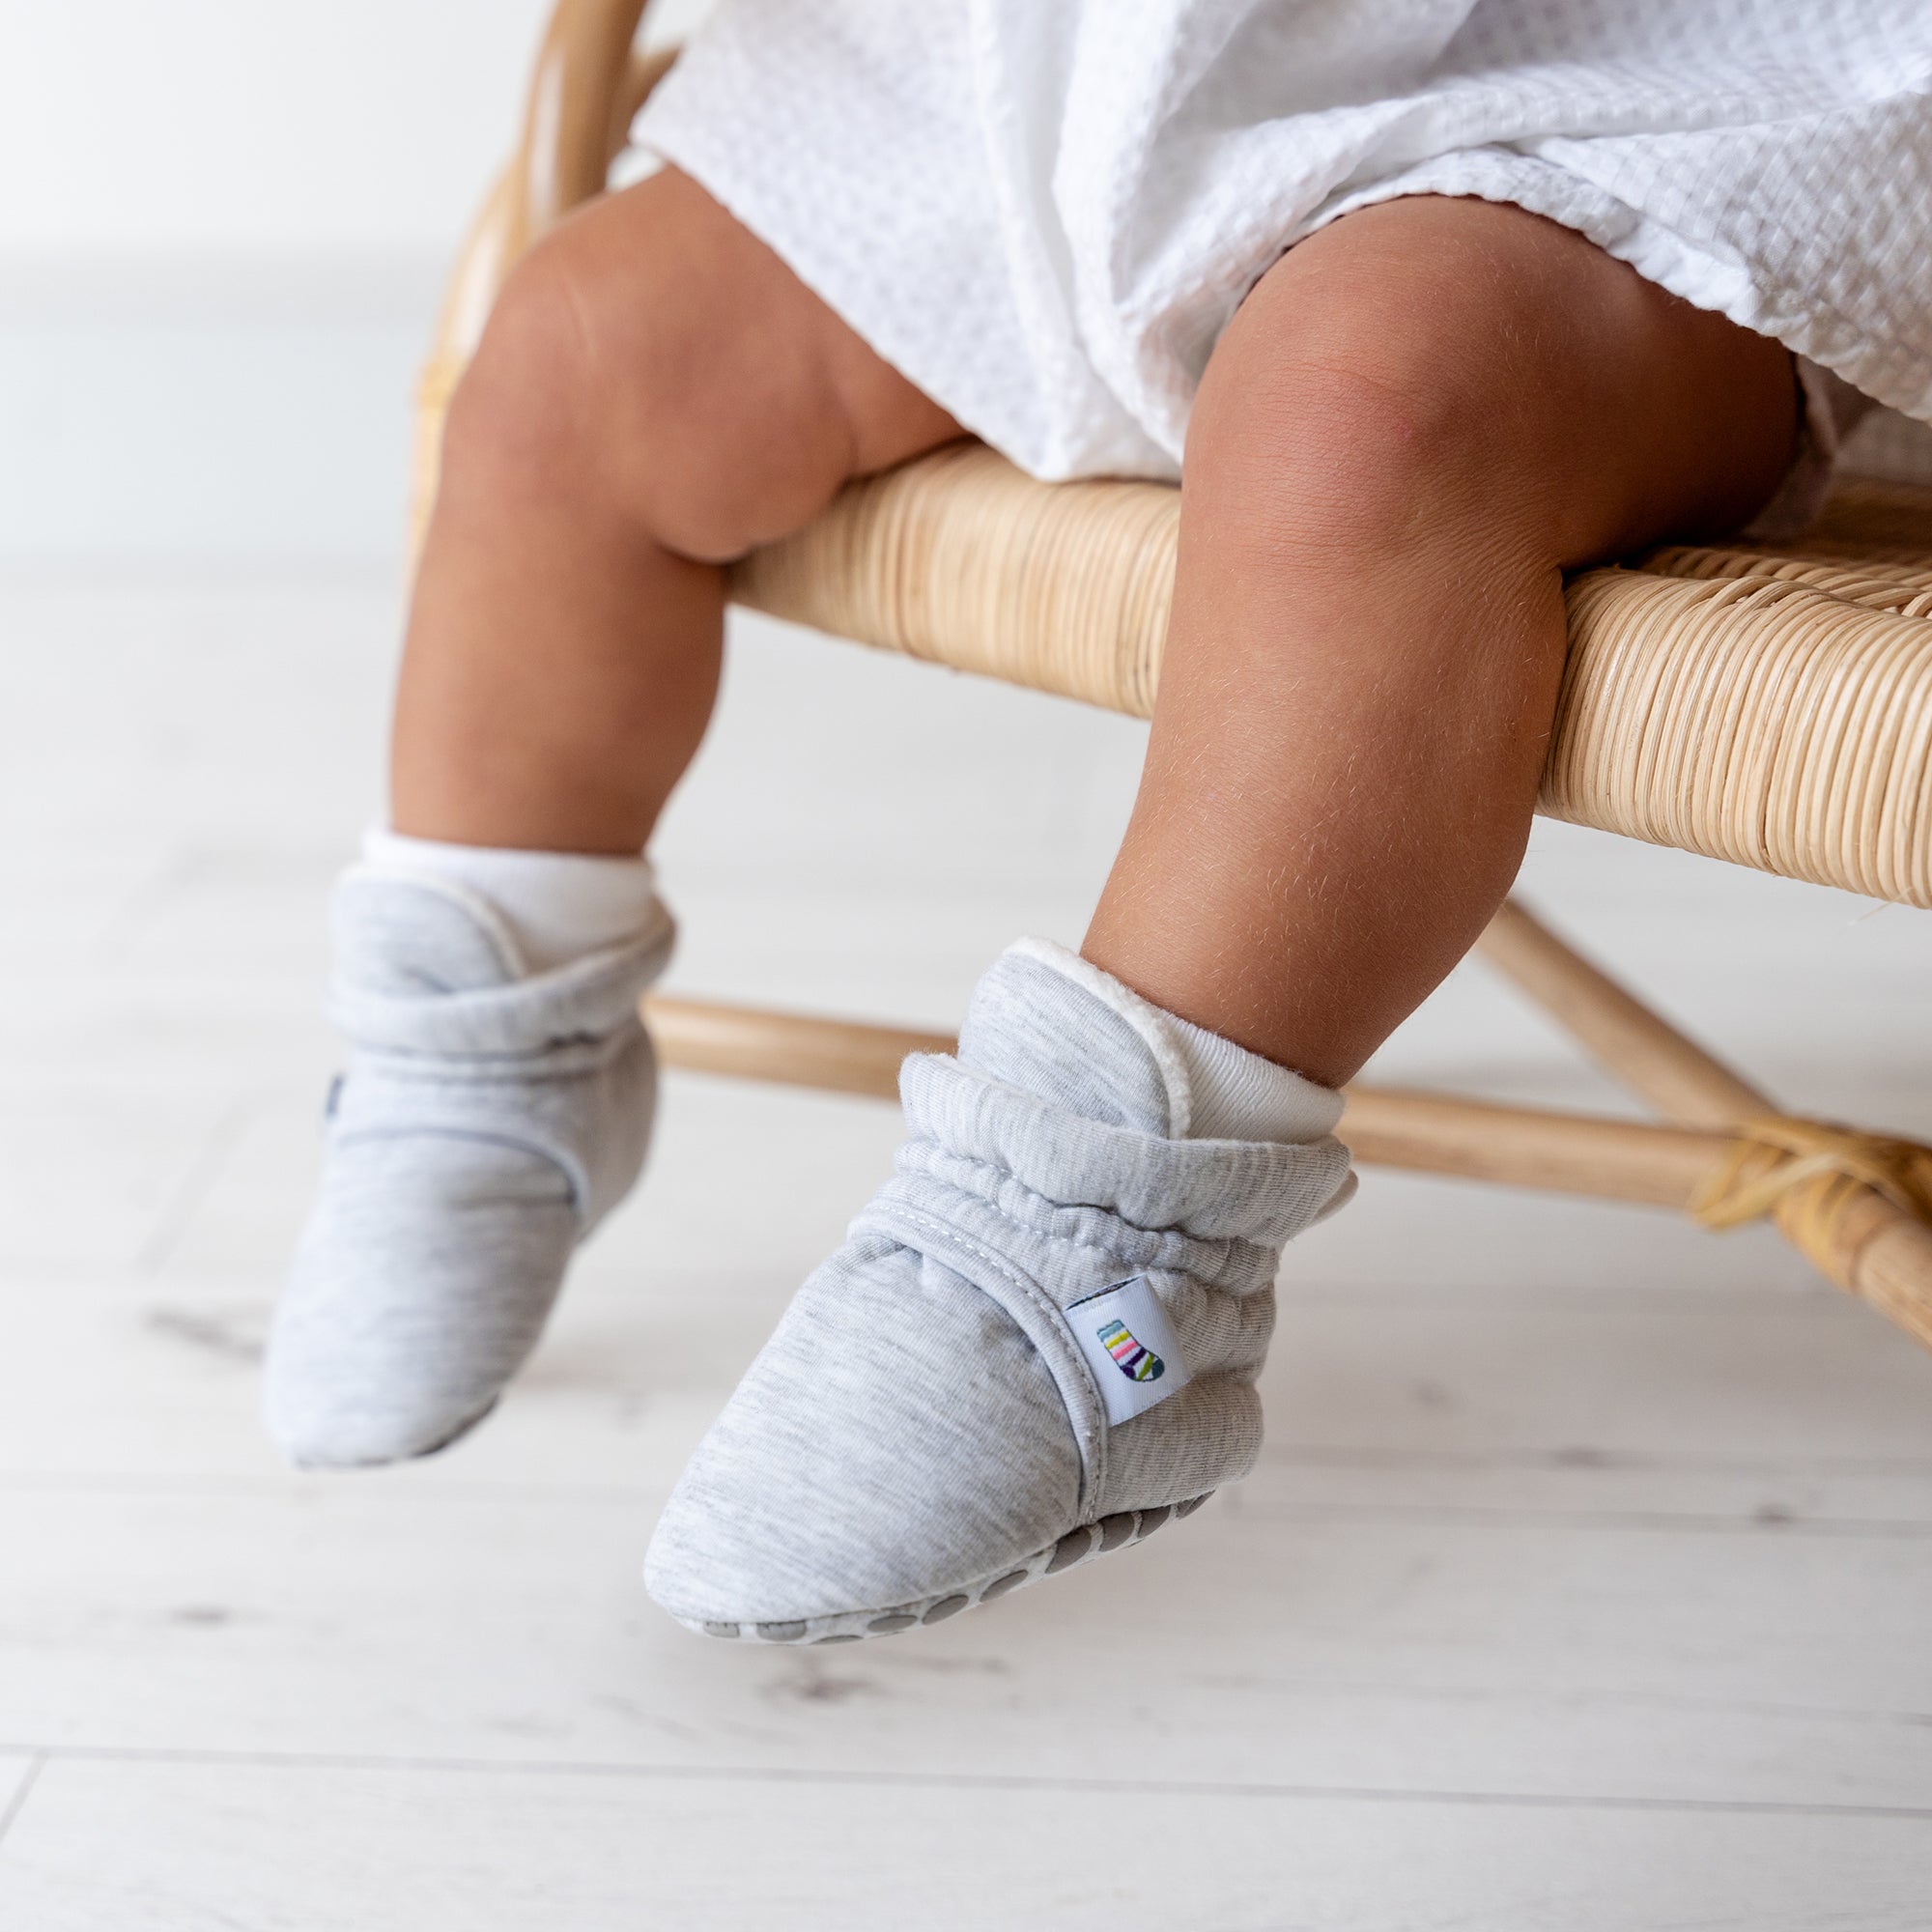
<box><xmin>1084</xmin><ymin>197</ymin><xmax>1797</xmax><ymax>1086</ymax></box>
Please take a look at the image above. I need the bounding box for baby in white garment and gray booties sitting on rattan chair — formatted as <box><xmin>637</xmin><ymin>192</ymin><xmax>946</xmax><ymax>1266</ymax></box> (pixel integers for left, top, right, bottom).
<box><xmin>269</xmin><ymin>0</ymin><xmax>1932</xmax><ymax>1642</ymax></box>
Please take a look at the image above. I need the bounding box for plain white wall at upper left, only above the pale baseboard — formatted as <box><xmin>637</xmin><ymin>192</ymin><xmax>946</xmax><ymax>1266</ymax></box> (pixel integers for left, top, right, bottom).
<box><xmin>0</xmin><ymin>0</ymin><xmax>560</xmax><ymax>257</ymax></box>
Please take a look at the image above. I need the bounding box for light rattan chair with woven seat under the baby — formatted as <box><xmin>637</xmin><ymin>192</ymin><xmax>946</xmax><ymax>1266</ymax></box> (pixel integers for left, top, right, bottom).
<box><xmin>417</xmin><ymin>0</ymin><xmax>1932</xmax><ymax>1345</ymax></box>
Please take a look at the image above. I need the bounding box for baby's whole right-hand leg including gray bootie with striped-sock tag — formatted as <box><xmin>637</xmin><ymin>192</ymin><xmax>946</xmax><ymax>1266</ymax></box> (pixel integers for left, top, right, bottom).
<box><xmin>645</xmin><ymin>201</ymin><xmax>1795</xmax><ymax>1642</ymax></box>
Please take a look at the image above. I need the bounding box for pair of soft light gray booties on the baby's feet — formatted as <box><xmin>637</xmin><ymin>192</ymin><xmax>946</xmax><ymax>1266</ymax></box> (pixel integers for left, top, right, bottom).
<box><xmin>267</xmin><ymin>871</ymin><xmax>1349</xmax><ymax>1642</ymax></box>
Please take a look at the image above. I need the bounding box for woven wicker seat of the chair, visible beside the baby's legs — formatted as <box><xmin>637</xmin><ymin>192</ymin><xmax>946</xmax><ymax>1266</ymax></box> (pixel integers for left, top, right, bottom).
<box><xmin>732</xmin><ymin>446</ymin><xmax>1932</xmax><ymax>906</ymax></box>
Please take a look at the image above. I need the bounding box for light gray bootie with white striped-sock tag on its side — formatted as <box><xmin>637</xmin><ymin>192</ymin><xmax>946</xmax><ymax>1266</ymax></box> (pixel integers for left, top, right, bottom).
<box><xmin>645</xmin><ymin>941</ymin><xmax>1349</xmax><ymax>1642</ymax></box>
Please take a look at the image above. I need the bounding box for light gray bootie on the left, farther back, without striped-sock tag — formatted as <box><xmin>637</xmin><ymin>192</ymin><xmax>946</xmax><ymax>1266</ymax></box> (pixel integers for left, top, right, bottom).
<box><xmin>265</xmin><ymin>869</ymin><xmax>674</xmax><ymax>1466</ymax></box>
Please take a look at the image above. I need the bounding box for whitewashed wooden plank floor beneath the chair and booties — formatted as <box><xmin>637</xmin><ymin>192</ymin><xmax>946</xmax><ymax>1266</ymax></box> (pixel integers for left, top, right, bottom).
<box><xmin>0</xmin><ymin>576</ymin><xmax>1932</xmax><ymax>1932</ymax></box>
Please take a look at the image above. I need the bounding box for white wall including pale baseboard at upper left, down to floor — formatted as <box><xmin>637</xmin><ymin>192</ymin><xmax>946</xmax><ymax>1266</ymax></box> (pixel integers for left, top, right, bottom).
<box><xmin>0</xmin><ymin>0</ymin><xmax>703</xmax><ymax>568</ymax></box>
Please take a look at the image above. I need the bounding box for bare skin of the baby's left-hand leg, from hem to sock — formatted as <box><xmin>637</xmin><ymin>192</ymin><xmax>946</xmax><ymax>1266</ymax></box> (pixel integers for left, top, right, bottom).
<box><xmin>390</xmin><ymin>170</ymin><xmax>958</xmax><ymax>854</ymax></box>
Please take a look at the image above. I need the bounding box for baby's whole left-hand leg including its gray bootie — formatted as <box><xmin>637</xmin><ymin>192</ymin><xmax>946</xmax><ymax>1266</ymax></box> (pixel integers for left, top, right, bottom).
<box><xmin>267</xmin><ymin>174</ymin><xmax>956</xmax><ymax>1463</ymax></box>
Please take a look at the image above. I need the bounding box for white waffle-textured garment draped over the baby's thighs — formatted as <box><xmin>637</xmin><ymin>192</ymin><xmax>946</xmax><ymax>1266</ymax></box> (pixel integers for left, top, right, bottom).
<box><xmin>638</xmin><ymin>0</ymin><xmax>1932</xmax><ymax>477</ymax></box>
